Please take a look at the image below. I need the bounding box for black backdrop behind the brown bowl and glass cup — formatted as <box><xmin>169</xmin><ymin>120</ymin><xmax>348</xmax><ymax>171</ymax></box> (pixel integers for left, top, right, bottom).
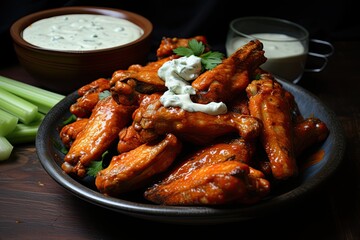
<box><xmin>0</xmin><ymin>0</ymin><xmax>360</xmax><ymax>64</ymax></box>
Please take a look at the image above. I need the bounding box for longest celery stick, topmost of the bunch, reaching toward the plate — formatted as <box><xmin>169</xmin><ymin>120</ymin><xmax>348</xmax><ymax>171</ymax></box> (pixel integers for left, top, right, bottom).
<box><xmin>0</xmin><ymin>76</ymin><xmax>65</xmax><ymax>114</ymax></box>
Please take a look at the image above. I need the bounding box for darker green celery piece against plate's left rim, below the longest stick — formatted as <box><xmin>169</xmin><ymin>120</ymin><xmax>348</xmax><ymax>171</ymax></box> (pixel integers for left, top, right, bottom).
<box><xmin>6</xmin><ymin>113</ymin><xmax>45</xmax><ymax>145</ymax></box>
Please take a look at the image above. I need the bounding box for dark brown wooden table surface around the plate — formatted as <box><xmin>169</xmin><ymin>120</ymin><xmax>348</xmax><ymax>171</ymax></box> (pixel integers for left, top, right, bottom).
<box><xmin>0</xmin><ymin>42</ymin><xmax>360</xmax><ymax>240</ymax></box>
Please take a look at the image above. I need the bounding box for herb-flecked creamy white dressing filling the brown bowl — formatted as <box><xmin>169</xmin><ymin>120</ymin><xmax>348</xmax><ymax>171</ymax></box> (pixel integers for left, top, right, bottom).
<box><xmin>23</xmin><ymin>14</ymin><xmax>144</xmax><ymax>51</ymax></box>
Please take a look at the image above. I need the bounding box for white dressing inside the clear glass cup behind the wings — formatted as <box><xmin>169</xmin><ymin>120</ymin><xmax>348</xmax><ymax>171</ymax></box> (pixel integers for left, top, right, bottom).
<box><xmin>226</xmin><ymin>33</ymin><xmax>307</xmax><ymax>81</ymax></box>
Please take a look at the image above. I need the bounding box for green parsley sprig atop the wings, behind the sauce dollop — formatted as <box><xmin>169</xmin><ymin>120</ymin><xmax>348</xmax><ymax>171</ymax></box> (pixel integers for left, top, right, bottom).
<box><xmin>173</xmin><ymin>39</ymin><xmax>224</xmax><ymax>70</ymax></box>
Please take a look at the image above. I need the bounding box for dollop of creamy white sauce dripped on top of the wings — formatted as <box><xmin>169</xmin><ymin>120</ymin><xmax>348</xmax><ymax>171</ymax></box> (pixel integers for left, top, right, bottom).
<box><xmin>158</xmin><ymin>55</ymin><xmax>227</xmax><ymax>115</ymax></box>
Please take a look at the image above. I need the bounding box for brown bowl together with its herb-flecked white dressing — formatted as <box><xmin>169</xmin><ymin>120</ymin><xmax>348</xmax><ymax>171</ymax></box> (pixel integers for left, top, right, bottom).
<box><xmin>10</xmin><ymin>6</ymin><xmax>153</xmax><ymax>94</ymax></box>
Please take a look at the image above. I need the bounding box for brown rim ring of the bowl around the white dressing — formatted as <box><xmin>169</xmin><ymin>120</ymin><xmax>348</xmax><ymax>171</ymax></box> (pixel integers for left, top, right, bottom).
<box><xmin>10</xmin><ymin>6</ymin><xmax>153</xmax><ymax>54</ymax></box>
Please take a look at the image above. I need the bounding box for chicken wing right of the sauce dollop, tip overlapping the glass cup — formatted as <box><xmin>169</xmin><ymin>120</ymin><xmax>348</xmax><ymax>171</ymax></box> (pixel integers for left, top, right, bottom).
<box><xmin>191</xmin><ymin>40</ymin><xmax>266</xmax><ymax>104</ymax></box>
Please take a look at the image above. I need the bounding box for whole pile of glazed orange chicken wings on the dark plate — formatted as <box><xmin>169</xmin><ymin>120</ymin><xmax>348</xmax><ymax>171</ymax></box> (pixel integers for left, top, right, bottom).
<box><xmin>60</xmin><ymin>36</ymin><xmax>329</xmax><ymax>205</ymax></box>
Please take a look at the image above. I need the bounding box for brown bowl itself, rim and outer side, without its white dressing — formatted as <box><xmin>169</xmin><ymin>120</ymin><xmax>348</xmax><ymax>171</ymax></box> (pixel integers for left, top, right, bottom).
<box><xmin>10</xmin><ymin>6</ymin><xmax>153</xmax><ymax>94</ymax></box>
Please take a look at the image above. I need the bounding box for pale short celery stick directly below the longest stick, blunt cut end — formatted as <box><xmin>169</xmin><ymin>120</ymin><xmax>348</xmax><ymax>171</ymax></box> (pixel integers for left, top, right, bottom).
<box><xmin>0</xmin><ymin>87</ymin><xmax>38</xmax><ymax>124</ymax></box>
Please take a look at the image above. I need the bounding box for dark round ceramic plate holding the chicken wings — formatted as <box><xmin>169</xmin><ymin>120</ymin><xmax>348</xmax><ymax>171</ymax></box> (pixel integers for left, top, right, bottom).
<box><xmin>36</xmin><ymin>80</ymin><xmax>345</xmax><ymax>224</ymax></box>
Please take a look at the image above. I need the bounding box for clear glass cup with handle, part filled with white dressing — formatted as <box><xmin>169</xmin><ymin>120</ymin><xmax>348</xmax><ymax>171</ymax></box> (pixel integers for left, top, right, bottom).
<box><xmin>225</xmin><ymin>16</ymin><xmax>334</xmax><ymax>84</ymax></box>
